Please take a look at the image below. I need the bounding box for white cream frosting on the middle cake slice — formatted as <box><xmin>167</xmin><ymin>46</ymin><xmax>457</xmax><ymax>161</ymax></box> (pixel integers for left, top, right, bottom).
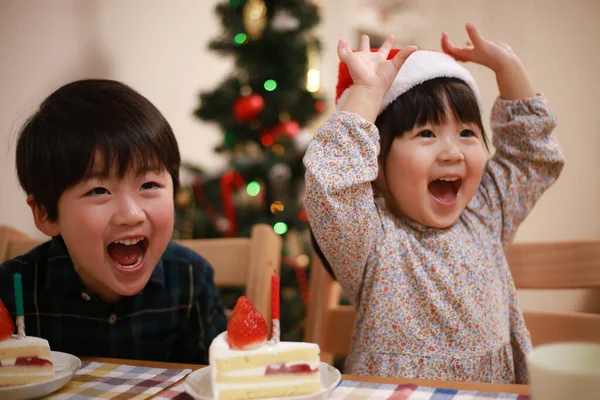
<box><xmin>208</xmin><ymin>332</ymin><xmax>320</xmax><ymax>399</ymax></box>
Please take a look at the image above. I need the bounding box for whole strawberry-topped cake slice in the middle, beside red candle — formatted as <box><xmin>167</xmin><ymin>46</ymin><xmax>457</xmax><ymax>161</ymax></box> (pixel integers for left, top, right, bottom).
<box><xmin>209</xmin><ymin>296</ymin><xmax>321</xmax><ymax>400</ymax></box>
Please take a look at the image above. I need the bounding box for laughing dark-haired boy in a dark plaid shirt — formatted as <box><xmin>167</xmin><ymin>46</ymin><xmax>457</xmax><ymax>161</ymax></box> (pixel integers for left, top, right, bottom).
<box><xmin>0</xmin><ymin>80</ymin><xmax>226</xmax><ymax>364</ymax></box>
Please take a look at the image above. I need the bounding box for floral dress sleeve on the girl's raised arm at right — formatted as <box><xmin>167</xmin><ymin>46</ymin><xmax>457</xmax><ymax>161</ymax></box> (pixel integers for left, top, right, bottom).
<box><xmin>470</xmin><ymin>95</ymin><xmax>564</xmax><ymax>245</ymax></box>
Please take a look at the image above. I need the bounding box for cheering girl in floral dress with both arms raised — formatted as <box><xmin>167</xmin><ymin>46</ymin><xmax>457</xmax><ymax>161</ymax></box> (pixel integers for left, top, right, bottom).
<box><xmin>305</xmin><ymin>24</ymin><xmax>564</xmax><ymax>383</ymax></box>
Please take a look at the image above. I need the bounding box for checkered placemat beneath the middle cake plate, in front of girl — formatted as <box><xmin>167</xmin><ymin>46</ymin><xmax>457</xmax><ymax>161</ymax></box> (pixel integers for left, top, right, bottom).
<box><xmin>155</xmin><ymin>381</ymin><xmax>529</xmax><ymax>400</ymax></box>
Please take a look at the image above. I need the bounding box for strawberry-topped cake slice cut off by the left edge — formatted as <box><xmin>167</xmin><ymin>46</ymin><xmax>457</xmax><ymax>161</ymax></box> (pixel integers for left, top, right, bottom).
<box><xmin>0</xmin><ymin>300</ymin><xmax>54</xmax><ymax>386</ymax></box>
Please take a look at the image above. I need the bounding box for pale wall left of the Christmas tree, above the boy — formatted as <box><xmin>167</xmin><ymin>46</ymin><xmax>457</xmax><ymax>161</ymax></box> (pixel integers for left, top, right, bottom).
<box><xmin>0</xmin><ymin>0</ymin><xmax>231</xmax><ymax>235</ymax></box>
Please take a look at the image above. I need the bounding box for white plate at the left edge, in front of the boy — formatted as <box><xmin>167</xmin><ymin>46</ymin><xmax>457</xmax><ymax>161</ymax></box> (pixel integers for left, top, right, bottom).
<box><xmin>0</xmin><ymin>351</ymin><xmax>81</xmax><ymax>400</ymax></box>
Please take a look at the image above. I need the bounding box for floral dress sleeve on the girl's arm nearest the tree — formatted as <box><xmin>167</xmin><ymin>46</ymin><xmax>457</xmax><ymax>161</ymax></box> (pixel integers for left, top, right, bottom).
<box><xmin>304</xmin><ymin>112</ymin><xmax>383</xmax><ymax>304</ymax></box>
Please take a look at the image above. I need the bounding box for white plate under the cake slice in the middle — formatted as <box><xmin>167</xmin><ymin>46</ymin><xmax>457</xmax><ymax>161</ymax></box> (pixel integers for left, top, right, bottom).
<box><xmin>184</xmin><ymin>362</ymin><xmax>342</xmax><ymax>400</ymax></box>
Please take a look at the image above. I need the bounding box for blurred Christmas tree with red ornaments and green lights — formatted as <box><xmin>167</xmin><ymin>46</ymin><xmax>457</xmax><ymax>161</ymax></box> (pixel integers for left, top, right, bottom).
<box><xmin>176</xmin><ymin>0</ymin><xmax>326</xmax><ymax>340</ymax></box>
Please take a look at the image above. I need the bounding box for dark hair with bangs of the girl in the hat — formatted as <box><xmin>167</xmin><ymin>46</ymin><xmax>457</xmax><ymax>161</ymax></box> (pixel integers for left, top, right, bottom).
<box><xmin>311</xmin><ymin>78</ymin><xmax>489</xmax><ymax>279</ymax></box>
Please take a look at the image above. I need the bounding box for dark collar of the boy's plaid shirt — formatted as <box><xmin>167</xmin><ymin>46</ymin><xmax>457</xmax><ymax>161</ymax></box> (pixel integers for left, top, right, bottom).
<box><xmin>44</xmin><ymin>235</ymin><xmax>165</xmax><ymax>292</ymax></box>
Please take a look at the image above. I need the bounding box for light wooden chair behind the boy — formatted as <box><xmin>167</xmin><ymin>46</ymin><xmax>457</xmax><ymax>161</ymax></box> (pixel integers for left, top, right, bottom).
<box><xmin>0</xmin><ymin>224</ymin><xmax>282</xmax><ymax>321</ymax></box>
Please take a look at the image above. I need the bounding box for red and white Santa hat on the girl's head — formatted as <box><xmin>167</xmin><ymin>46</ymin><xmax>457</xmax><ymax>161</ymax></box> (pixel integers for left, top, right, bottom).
<box><xmin>335</xmin><ymin>49</ymin><xmax>483</xmax><ymax>113</ymax></box>
